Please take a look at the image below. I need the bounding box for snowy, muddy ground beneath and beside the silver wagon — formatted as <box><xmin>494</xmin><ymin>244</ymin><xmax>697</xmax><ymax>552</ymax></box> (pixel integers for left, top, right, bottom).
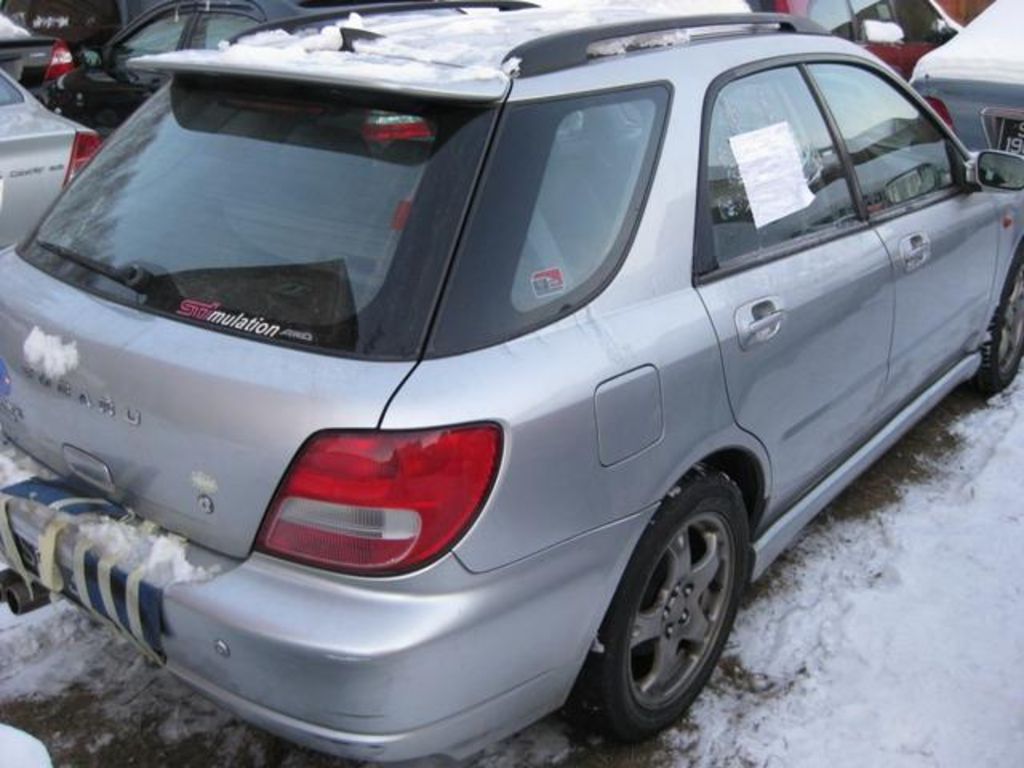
<box><xmin>0</xmin><ymin>386</ymin><xmax>1024</xmax><ymax>768</ymax></box>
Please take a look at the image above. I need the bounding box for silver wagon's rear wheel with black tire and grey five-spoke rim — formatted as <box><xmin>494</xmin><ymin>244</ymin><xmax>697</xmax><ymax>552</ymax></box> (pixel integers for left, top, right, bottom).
<box><xmin>566</xmin><ymin>468</ymin><xmax>750</xmax><ymax>742</ymax></box>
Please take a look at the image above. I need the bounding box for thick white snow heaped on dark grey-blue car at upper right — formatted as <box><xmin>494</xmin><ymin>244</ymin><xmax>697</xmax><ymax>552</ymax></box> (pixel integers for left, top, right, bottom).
<box><xmin>913</xmin><ymin>0</ymin><xmax>1024</xmax><ymax>85</ymax></box>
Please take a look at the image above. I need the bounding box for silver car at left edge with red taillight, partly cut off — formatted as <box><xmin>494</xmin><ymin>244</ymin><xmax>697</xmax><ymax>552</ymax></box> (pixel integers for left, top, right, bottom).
<box><xmin>0</xmin><ymin>67</ymin><xmax>99</xmax><ymax>246</ymax></box>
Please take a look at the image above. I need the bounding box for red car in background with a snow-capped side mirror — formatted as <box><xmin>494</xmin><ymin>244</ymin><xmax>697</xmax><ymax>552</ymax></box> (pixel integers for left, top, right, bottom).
<box><xmin>748</xmin><ymin>0</ymin><xmax>962</xmax><ymax>79</ymax></box>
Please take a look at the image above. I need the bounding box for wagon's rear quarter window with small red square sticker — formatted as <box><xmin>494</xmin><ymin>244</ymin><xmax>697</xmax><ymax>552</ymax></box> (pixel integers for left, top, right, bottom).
<box><xmin>430</xmin><ymin>86</ymin><xmax>668</xmax><ymax>355</ymax></box>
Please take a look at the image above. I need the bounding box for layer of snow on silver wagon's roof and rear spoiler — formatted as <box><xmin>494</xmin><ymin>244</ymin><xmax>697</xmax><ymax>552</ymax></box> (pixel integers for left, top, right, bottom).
<box><xmin>132</xmin><ymin>0</ymin><xmax>750</xmax><ymax>100</ymax></box>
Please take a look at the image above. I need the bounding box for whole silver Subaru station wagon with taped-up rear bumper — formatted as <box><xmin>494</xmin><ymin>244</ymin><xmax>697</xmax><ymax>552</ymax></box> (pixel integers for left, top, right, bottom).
<box><xmin>0</xmin><ymin>0</ymin><xmax>1024</xmax><ymax>763</ymax></box>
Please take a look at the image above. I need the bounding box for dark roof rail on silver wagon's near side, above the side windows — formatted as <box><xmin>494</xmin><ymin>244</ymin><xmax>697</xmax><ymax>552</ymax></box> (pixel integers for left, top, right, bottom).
<box><xmin>505</xmin><ymin>13</ymin><xmax>828</xmax><ymax>77</ymax></box>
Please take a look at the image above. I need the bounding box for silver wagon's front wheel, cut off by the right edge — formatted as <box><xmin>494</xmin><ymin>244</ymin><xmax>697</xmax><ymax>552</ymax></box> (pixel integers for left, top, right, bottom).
<box><xmin>973</xmin><ymin>249</ymin><xmax>1024</xmax><ymax>396</ymax></box>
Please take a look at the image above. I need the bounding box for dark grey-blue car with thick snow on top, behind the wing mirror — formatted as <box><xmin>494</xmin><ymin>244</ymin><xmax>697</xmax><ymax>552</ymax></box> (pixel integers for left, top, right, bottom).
<box><xmin>912</xmin><ymin>0</ymin><xmax>1024</xmax><ymax>155</ymax></box>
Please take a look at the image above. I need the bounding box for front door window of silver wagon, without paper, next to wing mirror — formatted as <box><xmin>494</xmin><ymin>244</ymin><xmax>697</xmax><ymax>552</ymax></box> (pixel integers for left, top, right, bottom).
<box><xmin>810</xmin><ymin>65</ymin><xmax>953</xmax><ymax>213</ymax></box>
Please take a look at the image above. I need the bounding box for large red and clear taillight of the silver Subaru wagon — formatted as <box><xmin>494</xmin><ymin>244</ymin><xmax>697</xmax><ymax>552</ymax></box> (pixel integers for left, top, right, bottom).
<box><xmin>256</xmin><ymin>424</ymin><xmax>502</xmax><ymax>574</ymax></box>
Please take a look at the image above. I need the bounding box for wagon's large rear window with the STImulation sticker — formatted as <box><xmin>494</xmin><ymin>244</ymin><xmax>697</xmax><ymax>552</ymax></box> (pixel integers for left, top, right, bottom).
<box><xmin>23</xmin><ymin>79</ymin><xmax>493</xmax><ymax>359</ymax></box>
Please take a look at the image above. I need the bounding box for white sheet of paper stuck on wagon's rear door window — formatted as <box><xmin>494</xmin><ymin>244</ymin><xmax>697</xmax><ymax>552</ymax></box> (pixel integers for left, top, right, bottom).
<box><xmin>729</xmin><ymin>123</ymin><xmax>814</xmax><ymax>229</ymax></box>
